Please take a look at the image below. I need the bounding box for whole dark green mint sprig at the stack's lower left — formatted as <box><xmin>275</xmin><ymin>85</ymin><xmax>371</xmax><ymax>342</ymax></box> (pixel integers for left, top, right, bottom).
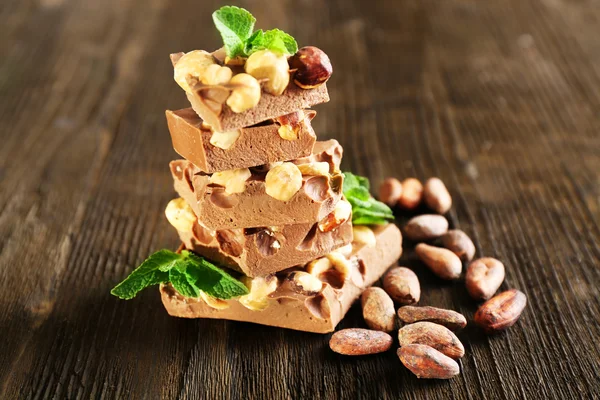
<box><xmin>110</xmin><ymin>250</ymin><xmax>249</xmax><ymax>300</ymax></box>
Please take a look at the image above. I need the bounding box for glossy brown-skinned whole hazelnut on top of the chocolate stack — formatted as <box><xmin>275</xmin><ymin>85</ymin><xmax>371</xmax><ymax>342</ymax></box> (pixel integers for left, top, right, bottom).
<box><xmin>289</xmin><ymin>46</ymin><xmax>333</xmax><ymax>89</ymax></box>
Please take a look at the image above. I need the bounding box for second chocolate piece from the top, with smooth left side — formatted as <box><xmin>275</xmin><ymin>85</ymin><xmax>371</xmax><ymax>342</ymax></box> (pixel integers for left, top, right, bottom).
<box><xmin>166</xmin><ymin>108</ymin><xmax>316</xmax><ymax>173</ymax></box>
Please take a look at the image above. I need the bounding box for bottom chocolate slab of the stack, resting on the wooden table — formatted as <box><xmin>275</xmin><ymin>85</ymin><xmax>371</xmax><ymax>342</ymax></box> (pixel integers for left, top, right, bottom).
<box><xmin>160</xmin><ymin>224</ymin><xmax>402</xmax><ymax>333</ymax></box>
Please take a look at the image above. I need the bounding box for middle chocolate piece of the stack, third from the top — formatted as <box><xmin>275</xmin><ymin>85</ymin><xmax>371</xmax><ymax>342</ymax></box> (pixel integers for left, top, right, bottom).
<box><xmin>170</xmin><ymin>140</ymin><xmax>343</xmax><ymax>230</ymax></box>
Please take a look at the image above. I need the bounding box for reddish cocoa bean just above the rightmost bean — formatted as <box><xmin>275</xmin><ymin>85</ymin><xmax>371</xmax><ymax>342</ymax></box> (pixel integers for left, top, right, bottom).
<box><xmin>465</xmin><ymin>257</ymin><xmax>505</xmax><ymax>300</ymax></box>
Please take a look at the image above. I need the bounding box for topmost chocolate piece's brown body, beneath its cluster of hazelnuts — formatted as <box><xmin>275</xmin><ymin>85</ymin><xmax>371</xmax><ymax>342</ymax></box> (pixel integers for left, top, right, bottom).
<box><xmin>187</xmin><ymin>81</ymin><xmax>329</xmax><ymax>132</ymax></box>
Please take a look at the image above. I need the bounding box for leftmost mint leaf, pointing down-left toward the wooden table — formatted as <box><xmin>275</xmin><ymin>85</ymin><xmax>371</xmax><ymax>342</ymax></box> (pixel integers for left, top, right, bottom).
<box><xmin>110</xmin><ymin>250</ymin><xmax>181</xmax><ymax>300</ymax></box>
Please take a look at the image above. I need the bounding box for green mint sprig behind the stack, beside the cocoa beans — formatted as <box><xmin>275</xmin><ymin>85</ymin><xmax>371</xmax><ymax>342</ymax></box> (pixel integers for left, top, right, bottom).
<box><xmin>343</xmin><ymin>172</ymin><xmax>394</xmax><ymax>225</ymax></box>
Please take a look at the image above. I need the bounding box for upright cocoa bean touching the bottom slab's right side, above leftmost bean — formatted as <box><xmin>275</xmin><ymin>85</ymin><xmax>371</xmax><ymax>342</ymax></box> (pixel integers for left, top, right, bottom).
<box><xmin>360</xmin><ymin>287</ymin><xmax>396</xmax><ymax>332</ymax></box>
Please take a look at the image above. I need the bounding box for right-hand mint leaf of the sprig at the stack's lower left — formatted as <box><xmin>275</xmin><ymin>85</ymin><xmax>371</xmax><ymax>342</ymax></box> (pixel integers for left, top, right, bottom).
<box><xmin>181</xmin><ymin>250</ymin><xmax>249</xmax><ymax>300</ymax></box>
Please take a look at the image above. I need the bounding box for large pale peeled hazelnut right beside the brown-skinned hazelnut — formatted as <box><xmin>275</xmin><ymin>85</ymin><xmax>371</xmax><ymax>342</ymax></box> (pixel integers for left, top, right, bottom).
<box><xmin>244</xmin><ymin>50</ymin><xmax>290</xmax><ymax>96</ymax></box>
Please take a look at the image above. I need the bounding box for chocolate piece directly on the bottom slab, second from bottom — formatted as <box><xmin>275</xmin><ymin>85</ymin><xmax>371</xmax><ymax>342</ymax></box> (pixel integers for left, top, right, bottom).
<box><xmin>177</xmin><ymin>200</ymin><xmax>352</xmax><ymax>277</ymax></box>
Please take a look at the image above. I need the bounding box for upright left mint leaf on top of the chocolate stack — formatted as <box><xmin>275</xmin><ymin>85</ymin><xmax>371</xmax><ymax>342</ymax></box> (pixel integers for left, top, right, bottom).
<box><xmin>212</xmin><ymin>6</ymin><xmax>256</xmax><ymax>58</ymax></box>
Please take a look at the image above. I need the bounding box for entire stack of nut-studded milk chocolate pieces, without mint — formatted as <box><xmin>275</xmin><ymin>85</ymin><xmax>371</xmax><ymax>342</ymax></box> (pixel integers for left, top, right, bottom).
<box><xmin>161</xmin><ymin>43</ymin><xmax>401</xmax><ymax>332</ymax></box>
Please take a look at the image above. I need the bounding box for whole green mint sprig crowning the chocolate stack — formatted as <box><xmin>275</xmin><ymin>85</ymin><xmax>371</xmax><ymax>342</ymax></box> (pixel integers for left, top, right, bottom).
<box><xmin>212</xmin><ymin>6</ymin><xmax>298</xmax><ymax>58</ymax></box>
